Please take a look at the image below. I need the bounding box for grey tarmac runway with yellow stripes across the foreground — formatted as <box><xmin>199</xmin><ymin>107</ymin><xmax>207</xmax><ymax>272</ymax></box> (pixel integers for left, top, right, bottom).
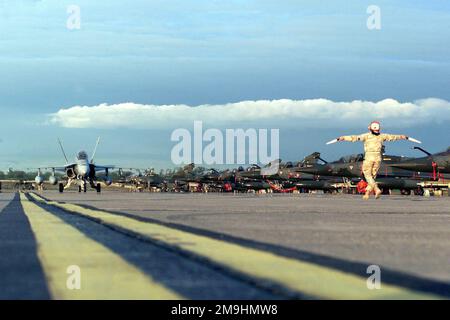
<box><xmin>0</xmin><ymin>191</ymin><xmax>450</xmax><ymax>299</ymax></box>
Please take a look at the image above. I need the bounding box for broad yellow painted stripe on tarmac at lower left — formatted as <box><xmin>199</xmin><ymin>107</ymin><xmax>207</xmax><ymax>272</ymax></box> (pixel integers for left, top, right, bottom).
<box><xmin>20</xmin><ymin>193</ymin><xmax>182</xmax><ymax>300</ymax></box>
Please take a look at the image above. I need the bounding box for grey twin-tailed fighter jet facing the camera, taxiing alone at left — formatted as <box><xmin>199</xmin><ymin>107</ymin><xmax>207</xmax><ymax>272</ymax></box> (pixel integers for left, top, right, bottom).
<box><xmin>35</xmin><ymin>138</ymin><xmax>114</xmax><ymax>193</ymax></box>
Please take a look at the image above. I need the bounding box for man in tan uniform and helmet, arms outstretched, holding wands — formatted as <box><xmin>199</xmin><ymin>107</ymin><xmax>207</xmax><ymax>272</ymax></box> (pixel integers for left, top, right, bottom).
<box><xmin>337</xmin><ymin>121</ymin><xmax>408</xmax><ymax>200</ymax></box>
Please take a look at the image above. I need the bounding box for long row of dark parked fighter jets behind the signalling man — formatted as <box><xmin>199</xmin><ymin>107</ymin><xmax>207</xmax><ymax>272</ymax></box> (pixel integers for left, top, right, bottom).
<box><xmin>117</xmin><ymin>147</ymin><xmax>450</xmax><ymax>194</ymax></box>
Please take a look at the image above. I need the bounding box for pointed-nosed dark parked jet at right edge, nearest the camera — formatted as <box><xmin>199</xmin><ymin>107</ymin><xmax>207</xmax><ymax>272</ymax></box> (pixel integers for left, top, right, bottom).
<box><xmin>389</xmin><ymin>147</ymin><xmax>450</xmax><ymax>180</ymax></box>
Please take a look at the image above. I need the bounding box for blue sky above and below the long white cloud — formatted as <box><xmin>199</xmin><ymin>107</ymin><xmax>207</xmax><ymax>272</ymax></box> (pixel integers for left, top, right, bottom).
<box><xmin>0</xmin><ymin>0</ymin><xmax>450</xmax><ymax>169</ymax></box>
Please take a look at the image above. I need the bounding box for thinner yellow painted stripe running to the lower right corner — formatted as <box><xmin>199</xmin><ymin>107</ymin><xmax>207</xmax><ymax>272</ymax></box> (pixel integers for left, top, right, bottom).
<box><xmin>31</xmin><ymin>194</ymin><xmax>439</xmax><ymax>299</ymax></box>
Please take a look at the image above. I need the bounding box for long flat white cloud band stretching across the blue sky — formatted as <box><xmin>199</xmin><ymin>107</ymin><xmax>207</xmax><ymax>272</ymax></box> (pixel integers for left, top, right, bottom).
<box><xmin>49</xmin><ymin>98</ymin><xmax>450</xmax><ymax>129</ymax></box>
